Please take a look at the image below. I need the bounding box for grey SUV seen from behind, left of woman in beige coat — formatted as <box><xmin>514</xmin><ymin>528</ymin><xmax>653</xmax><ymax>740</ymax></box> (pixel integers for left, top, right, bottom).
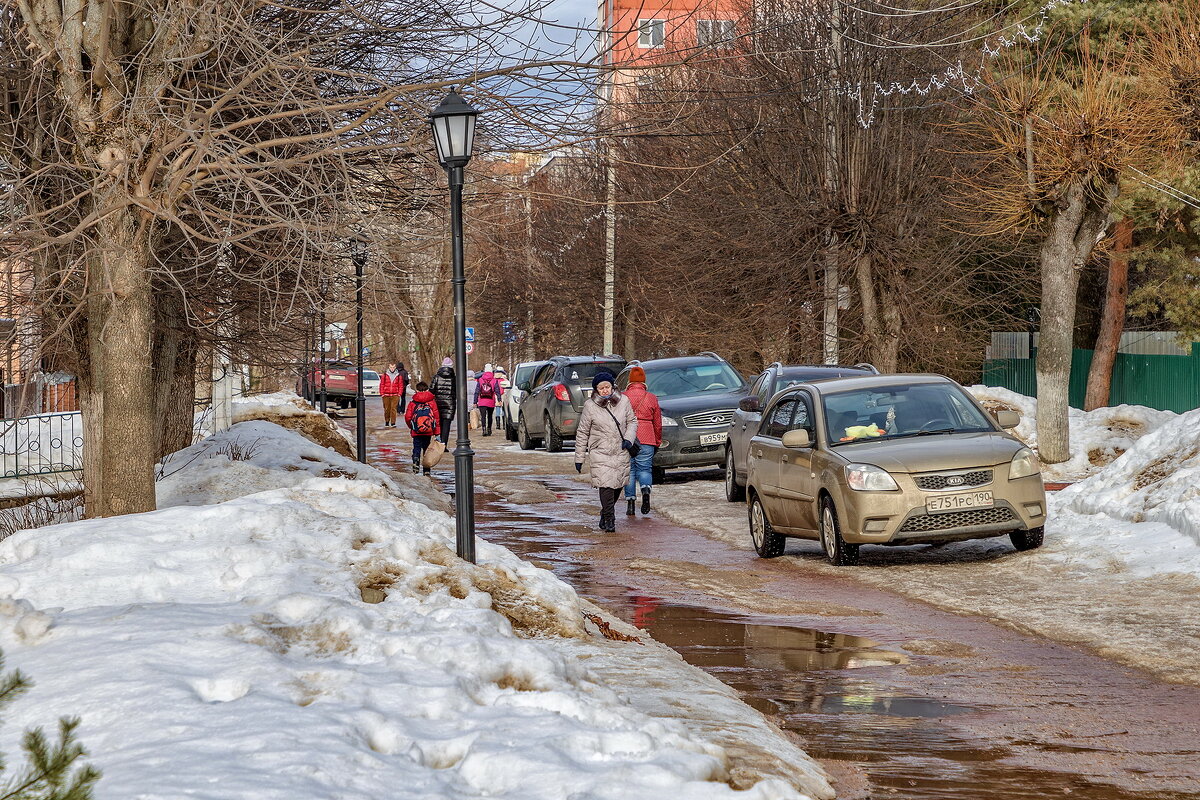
<box><xmin>517</xmin><ymin>355</ymin><xmax>625</xmax><ymax>452</ymax></box>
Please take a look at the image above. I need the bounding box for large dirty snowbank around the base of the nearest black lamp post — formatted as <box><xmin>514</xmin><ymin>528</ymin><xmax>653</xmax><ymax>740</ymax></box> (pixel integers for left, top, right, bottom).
<box><xmin>0</xmin><ymin>421</ymin><xmax>828</xmax><ymax>800</ymax></box>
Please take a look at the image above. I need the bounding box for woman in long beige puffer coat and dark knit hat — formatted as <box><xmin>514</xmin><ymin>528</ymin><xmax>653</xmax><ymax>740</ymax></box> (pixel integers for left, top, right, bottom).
<box><xmin>575</xmin><ymin>371</ymin><xmax>637</xmax><ymax>533</ymax></box>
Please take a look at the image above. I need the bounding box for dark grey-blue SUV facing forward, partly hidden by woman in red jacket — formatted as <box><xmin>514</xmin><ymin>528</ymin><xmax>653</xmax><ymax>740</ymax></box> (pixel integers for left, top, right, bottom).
<box><xmin>617</xmin><ymin>353</ymin><xmax>749</xmax><ymax>483</ymax></box>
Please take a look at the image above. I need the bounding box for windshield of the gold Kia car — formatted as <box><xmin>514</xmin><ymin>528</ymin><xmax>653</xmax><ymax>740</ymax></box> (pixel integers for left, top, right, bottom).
<box><xmin>823</xmin><ymin>384</ymin><xmax>995</xmax><ymax>445</ymax></box>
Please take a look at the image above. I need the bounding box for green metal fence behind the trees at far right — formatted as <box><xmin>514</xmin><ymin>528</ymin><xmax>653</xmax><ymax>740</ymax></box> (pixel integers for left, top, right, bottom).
<box><xmin>983</xmin><ymin>343</ymin><xmax>1200</xmax><ymax>413</ymax></box>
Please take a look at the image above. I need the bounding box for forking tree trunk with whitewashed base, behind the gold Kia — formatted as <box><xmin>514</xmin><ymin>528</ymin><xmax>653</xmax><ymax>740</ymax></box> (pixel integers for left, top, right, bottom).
<box><xmin>1037</xmin><ymin>180</ymin><xmax>1117</xmax><ymax>464</ymax></box>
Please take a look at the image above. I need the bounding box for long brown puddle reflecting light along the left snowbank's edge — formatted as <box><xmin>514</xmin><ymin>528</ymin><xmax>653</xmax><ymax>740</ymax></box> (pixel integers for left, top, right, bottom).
<box><xmin>369</xmin><ymin>443</ymin><xmax>1200</xmax><ymax>800</ymax></box>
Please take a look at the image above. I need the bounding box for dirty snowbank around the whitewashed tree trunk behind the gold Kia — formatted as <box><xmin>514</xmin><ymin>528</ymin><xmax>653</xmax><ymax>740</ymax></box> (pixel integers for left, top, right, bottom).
<box><xmin>967</xmin><ymin>386</ymin><xmax>1180</xmax><ymax>481</ymax></box>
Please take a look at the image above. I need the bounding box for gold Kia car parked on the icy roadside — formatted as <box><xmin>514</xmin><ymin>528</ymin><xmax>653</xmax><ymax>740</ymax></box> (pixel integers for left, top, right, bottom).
<box><xmin>746</xmin><ymin>375</ymin><xmax>1046</xmax><ymax>565</ymax></box>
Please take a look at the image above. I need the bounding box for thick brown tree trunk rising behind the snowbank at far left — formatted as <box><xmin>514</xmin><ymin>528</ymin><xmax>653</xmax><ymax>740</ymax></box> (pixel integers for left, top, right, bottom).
<box><xmin>84</xmin><ymin>209</ymin><xmax>155</xmax><ymax>517</ymax></box>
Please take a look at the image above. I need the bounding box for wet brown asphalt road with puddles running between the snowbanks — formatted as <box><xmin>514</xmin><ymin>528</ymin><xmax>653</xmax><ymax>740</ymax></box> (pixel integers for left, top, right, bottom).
<box><xmin>342</xmin><ymin>401</ymin><xmax>1200</xmax><ymax>800</ymax></box>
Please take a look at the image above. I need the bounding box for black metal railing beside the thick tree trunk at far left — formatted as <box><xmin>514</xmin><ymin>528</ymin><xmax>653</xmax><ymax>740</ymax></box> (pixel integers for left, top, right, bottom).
<box><xmin>0</xmin><ymin>411</ymin><xmax>83</xmax><ymax>477</ymax></box>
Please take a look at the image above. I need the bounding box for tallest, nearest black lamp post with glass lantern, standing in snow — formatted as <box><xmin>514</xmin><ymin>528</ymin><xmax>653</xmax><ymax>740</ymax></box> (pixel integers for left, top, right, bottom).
<box><xmin>430</xmin><ymin>89</ymin><xmax>479</xmax><ymax>564</ymax></box>
